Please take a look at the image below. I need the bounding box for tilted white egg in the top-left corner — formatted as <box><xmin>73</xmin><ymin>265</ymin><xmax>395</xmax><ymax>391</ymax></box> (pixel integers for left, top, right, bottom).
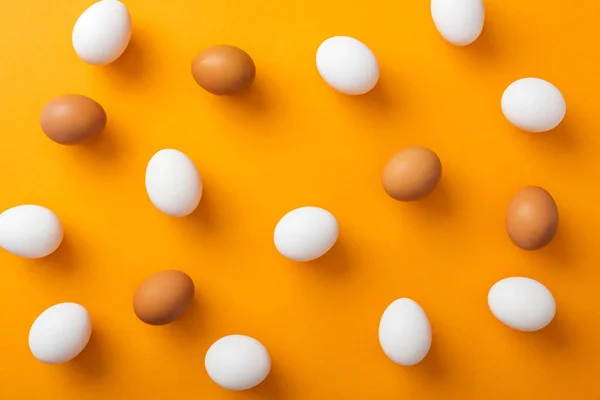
<box><xmin>72</xmin><ymin>0</ymin><xmax>131</xmax><ymax>65</ymax></box>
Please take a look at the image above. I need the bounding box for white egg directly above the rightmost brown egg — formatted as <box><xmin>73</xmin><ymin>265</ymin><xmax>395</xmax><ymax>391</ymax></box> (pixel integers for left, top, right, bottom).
<box><xmin>501</xmin><ymin>78</ymin><xmax>567</xmax><ymax>132</ymax></box>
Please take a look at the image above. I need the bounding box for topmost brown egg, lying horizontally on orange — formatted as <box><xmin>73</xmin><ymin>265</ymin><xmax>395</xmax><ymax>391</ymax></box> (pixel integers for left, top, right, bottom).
<box><xmin>192</xmin><ymin>45</ymin><xmax>256</xmax><ymax>95</ymax></box>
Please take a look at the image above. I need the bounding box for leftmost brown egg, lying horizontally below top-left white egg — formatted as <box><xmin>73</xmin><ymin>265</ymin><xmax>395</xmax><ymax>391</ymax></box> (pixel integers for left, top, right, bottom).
<box><xmin>40</xmin><ymin>94</ymin><xmax>106</xmax><ymax>145</ymax></box>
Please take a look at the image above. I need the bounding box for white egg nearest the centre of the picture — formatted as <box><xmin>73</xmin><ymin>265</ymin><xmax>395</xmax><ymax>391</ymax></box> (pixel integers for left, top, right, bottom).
<box><xmin>273</xmin><ymin>207</ymin><xmax>339</xmax><ymax>261</ymax></box>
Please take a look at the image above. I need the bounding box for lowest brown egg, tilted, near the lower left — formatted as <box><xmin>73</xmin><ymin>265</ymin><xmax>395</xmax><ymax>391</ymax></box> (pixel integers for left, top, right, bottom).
<box><xmin>133</xmin><ymin>270</ymin><xmax>194</xmax><ymax>325</ymax></box>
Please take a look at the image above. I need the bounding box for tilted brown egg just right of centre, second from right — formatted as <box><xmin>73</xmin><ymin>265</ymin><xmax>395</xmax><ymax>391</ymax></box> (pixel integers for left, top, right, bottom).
<box><xmin>382</xmin><ymin>147</ymin><xmax>442</xmax><ymax>201</ymax></box>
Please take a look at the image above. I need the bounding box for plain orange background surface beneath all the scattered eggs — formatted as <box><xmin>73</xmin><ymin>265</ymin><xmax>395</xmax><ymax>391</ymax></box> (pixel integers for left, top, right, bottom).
<box><xmin>0</xmin><ymin>0</ymin><xmax>600</xmax><ymax>400</ymax></box>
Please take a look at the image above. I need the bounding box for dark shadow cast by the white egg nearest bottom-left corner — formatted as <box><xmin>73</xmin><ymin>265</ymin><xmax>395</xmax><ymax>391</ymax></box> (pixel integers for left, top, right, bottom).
<box><xmin>67</xmin><ymin>324</ymin><xmax>110</xmax><ymax>380</ymax></box>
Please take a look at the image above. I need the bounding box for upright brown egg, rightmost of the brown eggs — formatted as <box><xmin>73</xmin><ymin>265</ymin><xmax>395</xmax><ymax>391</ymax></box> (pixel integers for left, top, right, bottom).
<box><xmin>506</xmin><ymin>186</ymin><xmax>558</xmax><ymax>250</ymax></box>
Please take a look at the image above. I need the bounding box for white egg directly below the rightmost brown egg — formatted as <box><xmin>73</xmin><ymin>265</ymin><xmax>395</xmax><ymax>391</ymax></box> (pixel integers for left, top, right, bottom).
<box><xmin>488</xmin><ymin>277</ymin><xmax>556</xmax><ymax>332</ymax></box>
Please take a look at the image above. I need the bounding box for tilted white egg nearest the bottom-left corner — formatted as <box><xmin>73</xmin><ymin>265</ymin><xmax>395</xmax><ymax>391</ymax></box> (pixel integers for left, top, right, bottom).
<box><xmin>29</xmin><ymin>303</ymin><xmax>92</xmax><ymax>364</ymax></box>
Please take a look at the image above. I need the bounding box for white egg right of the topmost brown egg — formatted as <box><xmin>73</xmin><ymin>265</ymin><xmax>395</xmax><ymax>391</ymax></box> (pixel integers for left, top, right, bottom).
<box><xmin>317</xmin><ymin>36</ymin><xmax>379</xmax><ymax>95</ymax></box>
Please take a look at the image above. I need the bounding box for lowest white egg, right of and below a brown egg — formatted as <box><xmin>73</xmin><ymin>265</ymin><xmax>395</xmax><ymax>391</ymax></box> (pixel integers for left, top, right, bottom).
<box><xmin>204</xmin><ymin>335</ymin><xmax>271</xmax><ymax>390</ymax></box>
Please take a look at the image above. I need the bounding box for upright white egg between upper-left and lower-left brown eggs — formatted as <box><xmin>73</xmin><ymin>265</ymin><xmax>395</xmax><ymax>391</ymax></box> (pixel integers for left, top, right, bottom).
<box><xmin>146</xmin><ymin>149</ymin><xmax>202</xmax><ymax>217</ymax></box>
